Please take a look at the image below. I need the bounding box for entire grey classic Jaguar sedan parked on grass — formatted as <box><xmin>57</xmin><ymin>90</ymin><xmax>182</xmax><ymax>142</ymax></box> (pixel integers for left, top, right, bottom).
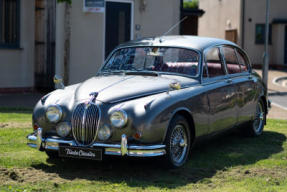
<box><xmin>27</xmin><ymin>36</ymin><xmax>268</xmax><ymax>167</ymax></box>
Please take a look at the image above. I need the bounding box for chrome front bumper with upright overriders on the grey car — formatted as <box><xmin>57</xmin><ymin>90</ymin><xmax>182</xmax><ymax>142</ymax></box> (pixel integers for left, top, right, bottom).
<box><xmin>27</xmin><ymin>128</ymin><xmax>166</xmax><ymax>157</ymax></box>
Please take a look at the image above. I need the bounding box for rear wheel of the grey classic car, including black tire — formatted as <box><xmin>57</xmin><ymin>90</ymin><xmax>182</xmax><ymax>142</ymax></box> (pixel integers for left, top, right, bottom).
<box><xmin>243</xmin><ymin>99</ymin><xmax>266</xmax><ymax>137</ymax></box>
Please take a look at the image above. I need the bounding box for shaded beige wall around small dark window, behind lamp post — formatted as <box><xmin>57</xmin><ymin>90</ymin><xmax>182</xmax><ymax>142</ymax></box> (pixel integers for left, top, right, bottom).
<box><xmin>244</xmin><ymin>0</ymin><xmax>287</xmax><ymax>65</ymax></box>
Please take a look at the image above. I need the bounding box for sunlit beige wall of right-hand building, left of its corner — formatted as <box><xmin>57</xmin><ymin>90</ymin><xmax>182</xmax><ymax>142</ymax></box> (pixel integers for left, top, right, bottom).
<box><xmin>198</xmin><ymin>0</ymin><xmax>244</xmax><ymax>45</ymax></box>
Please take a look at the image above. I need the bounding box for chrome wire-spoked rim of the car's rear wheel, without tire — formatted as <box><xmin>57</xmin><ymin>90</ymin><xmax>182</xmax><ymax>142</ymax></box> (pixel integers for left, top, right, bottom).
<box><xmin>253</xmin><ymin>101</ymin><xmax>265</xmax><ymax>135</ymax></box>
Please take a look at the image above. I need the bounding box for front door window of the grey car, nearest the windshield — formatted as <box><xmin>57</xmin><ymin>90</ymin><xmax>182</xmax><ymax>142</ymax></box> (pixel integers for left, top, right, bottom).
<box><xmin>205</xmin><ymin>47</ymin><xmax>225</xmax><ymax>77</ymax></box>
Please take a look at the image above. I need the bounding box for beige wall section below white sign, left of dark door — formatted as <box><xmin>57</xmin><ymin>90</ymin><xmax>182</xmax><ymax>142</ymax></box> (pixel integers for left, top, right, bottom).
<box><xmin>69</xmin><ymin>0</ymin><xmax>105</xmax><ymax>84</ymax></box>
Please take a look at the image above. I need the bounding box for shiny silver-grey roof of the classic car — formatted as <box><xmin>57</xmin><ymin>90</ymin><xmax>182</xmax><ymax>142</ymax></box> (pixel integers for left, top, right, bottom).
<box><xmin>118</xmin><ymin>35</ymin><xmax>238</xmax><ymax>51</ymax></box>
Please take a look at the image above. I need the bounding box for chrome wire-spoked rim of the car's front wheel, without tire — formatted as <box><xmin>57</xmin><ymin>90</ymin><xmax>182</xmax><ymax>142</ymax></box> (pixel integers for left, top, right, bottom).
<box><xmin>169</xmin><ymin>124</ymin><xmax>188</xmax><ymax>164</ymax></box>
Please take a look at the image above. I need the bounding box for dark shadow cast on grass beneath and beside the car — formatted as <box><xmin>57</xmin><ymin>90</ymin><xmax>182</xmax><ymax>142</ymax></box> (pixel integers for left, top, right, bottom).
<box><xmin>33</xmin><ymin>131</ymin><xmax>286</xmax><ymax>189</ymax></box>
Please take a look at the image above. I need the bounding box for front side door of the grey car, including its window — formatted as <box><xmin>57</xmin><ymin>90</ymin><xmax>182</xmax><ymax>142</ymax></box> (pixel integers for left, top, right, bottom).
<box><xmin>203</xmin><ymin>46</ymin><xmax>237</xmax><ymax>133</ymax></box>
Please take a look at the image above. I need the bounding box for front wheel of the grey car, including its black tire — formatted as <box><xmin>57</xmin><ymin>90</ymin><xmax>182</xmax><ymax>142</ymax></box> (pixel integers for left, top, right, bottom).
<box><xmin>165</xmin><ymin>115</ymin><xmax>191</xmax><ymax>168</ymax></box>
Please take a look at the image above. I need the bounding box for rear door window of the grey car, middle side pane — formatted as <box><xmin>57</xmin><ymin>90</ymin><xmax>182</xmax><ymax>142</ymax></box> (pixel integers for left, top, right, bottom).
<box><xmin>222</xmin><ymin>47</ymin><xmax>241</xmax><ymax>74</ymax></box>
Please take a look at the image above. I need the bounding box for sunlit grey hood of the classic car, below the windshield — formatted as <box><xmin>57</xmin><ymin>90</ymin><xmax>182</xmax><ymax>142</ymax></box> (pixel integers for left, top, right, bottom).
<box><xmin>74</xmin><ymin>75</ymin><xmax>198</xmax><ymax>103</ymax></box>
